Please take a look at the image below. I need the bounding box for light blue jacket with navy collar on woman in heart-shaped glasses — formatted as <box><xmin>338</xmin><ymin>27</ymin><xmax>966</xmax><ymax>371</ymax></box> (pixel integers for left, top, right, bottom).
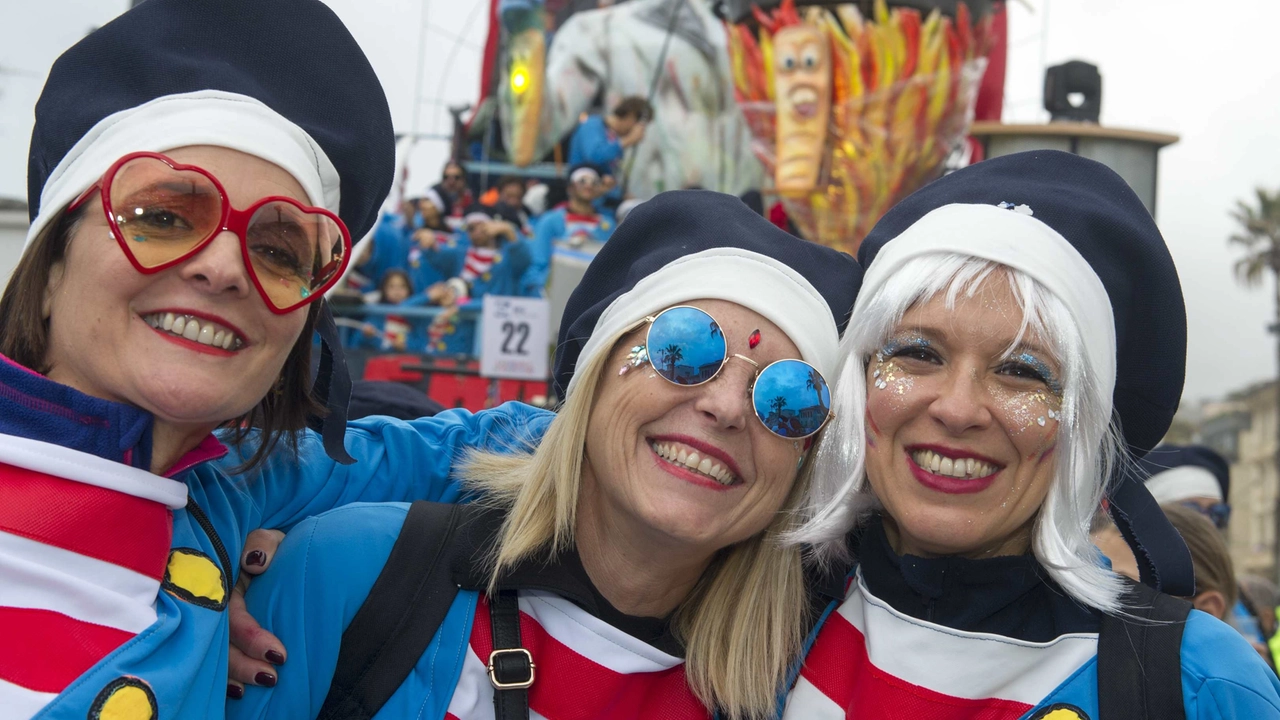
<box><xmin>0</xmin><ymin>348</ymin><xmax>552</xmax><ymax>720</ymax></box>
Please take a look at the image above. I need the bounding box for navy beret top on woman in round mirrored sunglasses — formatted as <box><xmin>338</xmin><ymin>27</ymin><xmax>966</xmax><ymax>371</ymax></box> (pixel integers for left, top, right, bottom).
<box><xmin>553</xmin><ymin>190</ymin><xmax>863</xmax><ymax>397</ymax></box>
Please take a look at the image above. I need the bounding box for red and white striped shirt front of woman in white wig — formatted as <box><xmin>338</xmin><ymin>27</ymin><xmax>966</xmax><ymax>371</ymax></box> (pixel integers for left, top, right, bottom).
<box><xmin>783</xmin><ymin>573</ymin><xmax>1098</xmax><ymax>720</ymax></box>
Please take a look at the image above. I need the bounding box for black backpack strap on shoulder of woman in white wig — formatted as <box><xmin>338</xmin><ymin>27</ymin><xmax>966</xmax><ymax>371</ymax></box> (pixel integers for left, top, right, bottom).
<box><xmin>1098</xmin><ymin>583</ymin><xmax>1192</xmax><ymax>720</ymax></box>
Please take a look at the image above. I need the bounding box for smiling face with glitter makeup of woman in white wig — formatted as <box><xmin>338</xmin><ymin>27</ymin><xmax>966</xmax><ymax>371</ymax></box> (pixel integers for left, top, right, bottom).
<box><xmin>867</xmin><ymin>274</ymin><xmax>1064</xmax><ymax>557</ymax></box>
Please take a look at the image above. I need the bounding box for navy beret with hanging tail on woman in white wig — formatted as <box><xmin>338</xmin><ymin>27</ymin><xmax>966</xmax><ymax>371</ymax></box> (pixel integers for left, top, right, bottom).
<box><xmin>858</xmin><ymin>150</ymin><xmax>1194</xmax><ymax>596</ymax></box>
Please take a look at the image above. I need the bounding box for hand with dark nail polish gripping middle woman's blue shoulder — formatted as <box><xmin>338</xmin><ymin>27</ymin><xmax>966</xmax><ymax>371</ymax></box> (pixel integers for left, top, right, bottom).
<box><xmin>227</xmin><ymin>529</ymin><xmax>288</xmax><ymax>700</ymax></box>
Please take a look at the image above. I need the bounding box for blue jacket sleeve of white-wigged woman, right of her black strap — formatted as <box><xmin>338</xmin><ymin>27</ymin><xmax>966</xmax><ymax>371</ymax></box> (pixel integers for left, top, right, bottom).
<box><xmin>1183</xmin><ymin>610</ymin><xmax>1280</xmax><ymax>720</ymax></box>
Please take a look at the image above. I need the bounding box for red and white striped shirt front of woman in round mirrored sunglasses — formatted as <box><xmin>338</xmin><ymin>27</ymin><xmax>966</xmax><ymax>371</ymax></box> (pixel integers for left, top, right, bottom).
<box><xmin>445</xmin><ymin>591</ymin><xmax>712</xmax><ymax>720</ymax></box>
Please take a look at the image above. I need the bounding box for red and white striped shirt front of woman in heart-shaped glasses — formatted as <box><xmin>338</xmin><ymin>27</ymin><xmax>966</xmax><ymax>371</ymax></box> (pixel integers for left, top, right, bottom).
<box><xmin>0</xmin><ymin>434</ymin><xmax>187</xmax><ymax>717</ymax></box>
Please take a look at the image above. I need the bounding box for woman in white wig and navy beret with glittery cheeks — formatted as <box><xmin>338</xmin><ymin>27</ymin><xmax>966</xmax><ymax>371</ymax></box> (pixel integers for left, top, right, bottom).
<box><xmin>785</xmin><ymin>151</ymin><xmax>1280</xmax><ymax>720</ymax></box>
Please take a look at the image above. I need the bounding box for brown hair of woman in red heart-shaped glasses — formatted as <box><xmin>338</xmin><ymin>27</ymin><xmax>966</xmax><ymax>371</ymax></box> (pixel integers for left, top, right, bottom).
<box><xmin>0</xmin><ymin>205</ymin><xmax>325</xmax><ymax>471</ymax></box>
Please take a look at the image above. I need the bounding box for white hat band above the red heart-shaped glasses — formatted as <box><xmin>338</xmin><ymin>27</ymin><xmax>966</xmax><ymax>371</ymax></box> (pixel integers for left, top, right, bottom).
<box><xmin>23</xmin><ymin>90</ymin><xmax>340</xmax><ymax>250</ymax></box>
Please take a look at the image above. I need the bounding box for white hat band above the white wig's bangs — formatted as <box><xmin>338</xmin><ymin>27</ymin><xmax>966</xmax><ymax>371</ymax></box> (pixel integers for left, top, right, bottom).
<box><xmin>852</xmin><ymin>204</ymin><xmax>1116</xmax><ymax>398</ymax></box>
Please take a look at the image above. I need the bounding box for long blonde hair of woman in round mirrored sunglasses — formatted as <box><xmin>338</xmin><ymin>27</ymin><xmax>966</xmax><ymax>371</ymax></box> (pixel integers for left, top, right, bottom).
<box><xmin>460</xmin><ymin>332</ymin><xmax>808</xmax><ymax>720</ymax></box>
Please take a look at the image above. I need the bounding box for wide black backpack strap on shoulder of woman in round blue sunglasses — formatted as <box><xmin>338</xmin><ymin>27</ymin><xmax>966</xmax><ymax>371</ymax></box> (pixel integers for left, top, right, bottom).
<box><xmin>317</xmin><ymin>501</ymin><xmax>468</xmax><ymax>720</ymax></box>
